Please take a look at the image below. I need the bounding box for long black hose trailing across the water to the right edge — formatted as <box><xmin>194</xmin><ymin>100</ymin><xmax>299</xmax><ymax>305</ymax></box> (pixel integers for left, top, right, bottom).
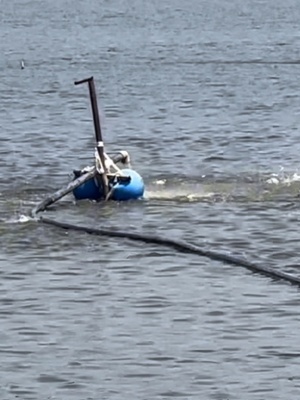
<box><xmin>39</xmin><ymin>217</ymin><xmax>300</xmax><ymax>287</ymax></box>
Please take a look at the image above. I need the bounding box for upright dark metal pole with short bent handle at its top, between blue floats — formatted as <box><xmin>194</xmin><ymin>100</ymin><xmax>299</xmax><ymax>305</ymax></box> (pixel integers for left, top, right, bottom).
<box><xmin>74</xmin><ymin>77</ymin><xmax>109</xmax><ymax>198</ymax></box>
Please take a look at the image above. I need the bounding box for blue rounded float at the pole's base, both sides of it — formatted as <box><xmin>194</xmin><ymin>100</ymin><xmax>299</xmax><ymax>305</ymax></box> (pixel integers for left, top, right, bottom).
<box><xmin>73</xmin><ymin>169</ymin><xmax>145</xmax><ymax>201</ymax></box>
